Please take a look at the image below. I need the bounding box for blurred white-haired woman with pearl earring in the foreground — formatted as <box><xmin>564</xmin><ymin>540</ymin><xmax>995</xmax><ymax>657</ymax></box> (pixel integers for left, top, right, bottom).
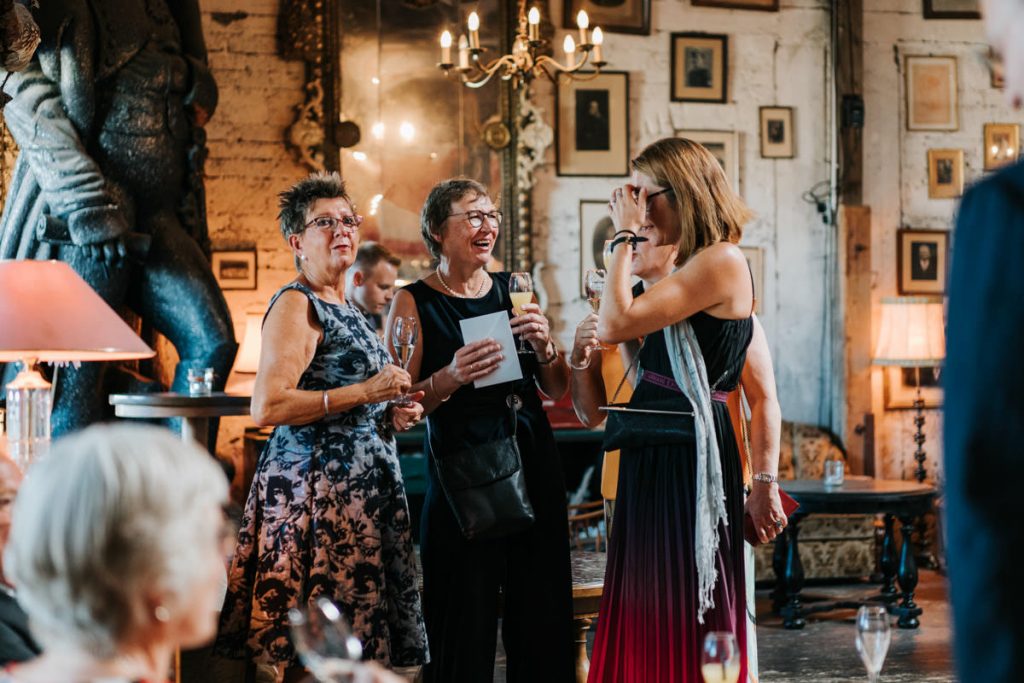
<box><xmin>0</xmin><ymin>425</ymin><xmax>227</xmax><ymax>683</ymax></box>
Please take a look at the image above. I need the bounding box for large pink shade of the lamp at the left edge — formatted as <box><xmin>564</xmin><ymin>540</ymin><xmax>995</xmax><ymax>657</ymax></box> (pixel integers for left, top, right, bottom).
<box><xmin>0</xmin><ymin>261</ymin><xmax>155</xmax><ymax>362</ymax></box>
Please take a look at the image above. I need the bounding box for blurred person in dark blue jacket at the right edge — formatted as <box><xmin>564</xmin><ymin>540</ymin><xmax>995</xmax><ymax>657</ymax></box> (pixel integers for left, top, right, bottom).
<box><xmin>942</xmin><ymin>0</ymin><xmax>1024</xmax><ymax>683</ymax></box>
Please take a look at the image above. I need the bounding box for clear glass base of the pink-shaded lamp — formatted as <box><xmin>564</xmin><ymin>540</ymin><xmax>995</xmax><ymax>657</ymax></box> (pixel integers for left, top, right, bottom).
<box><xmin>7</xmin><ymin>360</ymin><xmax>51</xmax><ymax>472</ymax></box>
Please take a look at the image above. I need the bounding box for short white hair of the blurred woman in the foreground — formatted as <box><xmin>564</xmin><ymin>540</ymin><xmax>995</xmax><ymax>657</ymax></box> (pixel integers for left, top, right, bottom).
<box><xmin>3</xmin><ymin>425</ymin><xmax>227</xmax><ymax>656</ymax></box>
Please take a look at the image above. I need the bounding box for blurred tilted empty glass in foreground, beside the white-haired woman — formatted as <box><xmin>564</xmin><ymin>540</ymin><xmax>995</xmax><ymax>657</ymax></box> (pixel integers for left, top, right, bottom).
<box><xmin>288</xmin><ymin>598</ymin><xmax>366</xmax><ymax>683</ymax></box>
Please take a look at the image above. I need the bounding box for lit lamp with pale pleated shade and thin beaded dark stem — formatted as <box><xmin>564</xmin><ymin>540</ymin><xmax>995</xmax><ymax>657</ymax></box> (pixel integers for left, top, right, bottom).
<box><xmin>874</xmin><ymin>297</ymin><xmax>946</xmax><ymax>481</ymax></box>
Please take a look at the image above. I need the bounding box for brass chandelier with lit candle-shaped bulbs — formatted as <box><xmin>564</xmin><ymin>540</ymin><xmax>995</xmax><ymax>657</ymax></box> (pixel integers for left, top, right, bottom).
<box><xmin>437</xmin><ymin>0</ymin><xmax>607</xmax><ymax>88</ymax></box>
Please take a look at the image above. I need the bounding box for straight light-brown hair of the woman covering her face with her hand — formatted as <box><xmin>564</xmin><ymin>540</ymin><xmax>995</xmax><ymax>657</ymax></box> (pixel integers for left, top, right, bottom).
<box><xmin>633</xmin><ymin>137</ymin><xmax>754</xmax><ymax>265</ymax></box>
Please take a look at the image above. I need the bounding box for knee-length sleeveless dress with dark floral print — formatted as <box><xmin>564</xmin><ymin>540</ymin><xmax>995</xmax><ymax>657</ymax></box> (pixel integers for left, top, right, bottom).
<box><xmin>217</xmin><ymin>283</ymin><xmax>427</xmax><ymax>667</ymax></box>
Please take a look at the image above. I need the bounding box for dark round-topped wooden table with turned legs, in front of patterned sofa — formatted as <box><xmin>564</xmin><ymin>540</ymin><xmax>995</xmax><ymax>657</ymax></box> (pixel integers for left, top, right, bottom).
<box><xmin>772</xmin><ymin>477</ymin><xmax>936</xmax><ymax>629</ymax></box>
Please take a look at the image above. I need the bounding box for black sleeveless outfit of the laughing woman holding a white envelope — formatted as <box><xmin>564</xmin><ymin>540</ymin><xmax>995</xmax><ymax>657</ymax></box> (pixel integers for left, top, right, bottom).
<box><xmin>406</xmin><ymin>273</ymin><xmax>574</xmax><ymax>683</ymax></box>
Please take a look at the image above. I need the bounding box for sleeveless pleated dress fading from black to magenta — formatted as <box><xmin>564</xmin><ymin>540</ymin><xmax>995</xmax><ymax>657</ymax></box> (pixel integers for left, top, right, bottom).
<box><xmin>588</xmin><ymin>312</ymin><xmax>754</xmax><ymax>683</ymax></box>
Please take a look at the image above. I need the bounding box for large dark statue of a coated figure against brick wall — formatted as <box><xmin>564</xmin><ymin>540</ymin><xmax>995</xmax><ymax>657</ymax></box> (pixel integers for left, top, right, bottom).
<box><xmin>0</xmin><ymin>0</ymin><xmax>237</xmax><ymax>434</ymax></box>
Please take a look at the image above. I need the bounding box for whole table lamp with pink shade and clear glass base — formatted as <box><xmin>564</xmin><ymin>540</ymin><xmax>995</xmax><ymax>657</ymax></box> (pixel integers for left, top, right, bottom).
<box><xmin>0</xmin><ymin>261</ymin><xmax>155</xmax><ymax>470</ymax></box>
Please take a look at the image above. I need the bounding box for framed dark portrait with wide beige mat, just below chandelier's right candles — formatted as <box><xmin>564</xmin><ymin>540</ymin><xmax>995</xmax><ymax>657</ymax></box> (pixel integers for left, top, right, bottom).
<box><xmin>555</xmin><ymin>72</ymin><xmax>630</xmax><ymax>177</ymax></box>
